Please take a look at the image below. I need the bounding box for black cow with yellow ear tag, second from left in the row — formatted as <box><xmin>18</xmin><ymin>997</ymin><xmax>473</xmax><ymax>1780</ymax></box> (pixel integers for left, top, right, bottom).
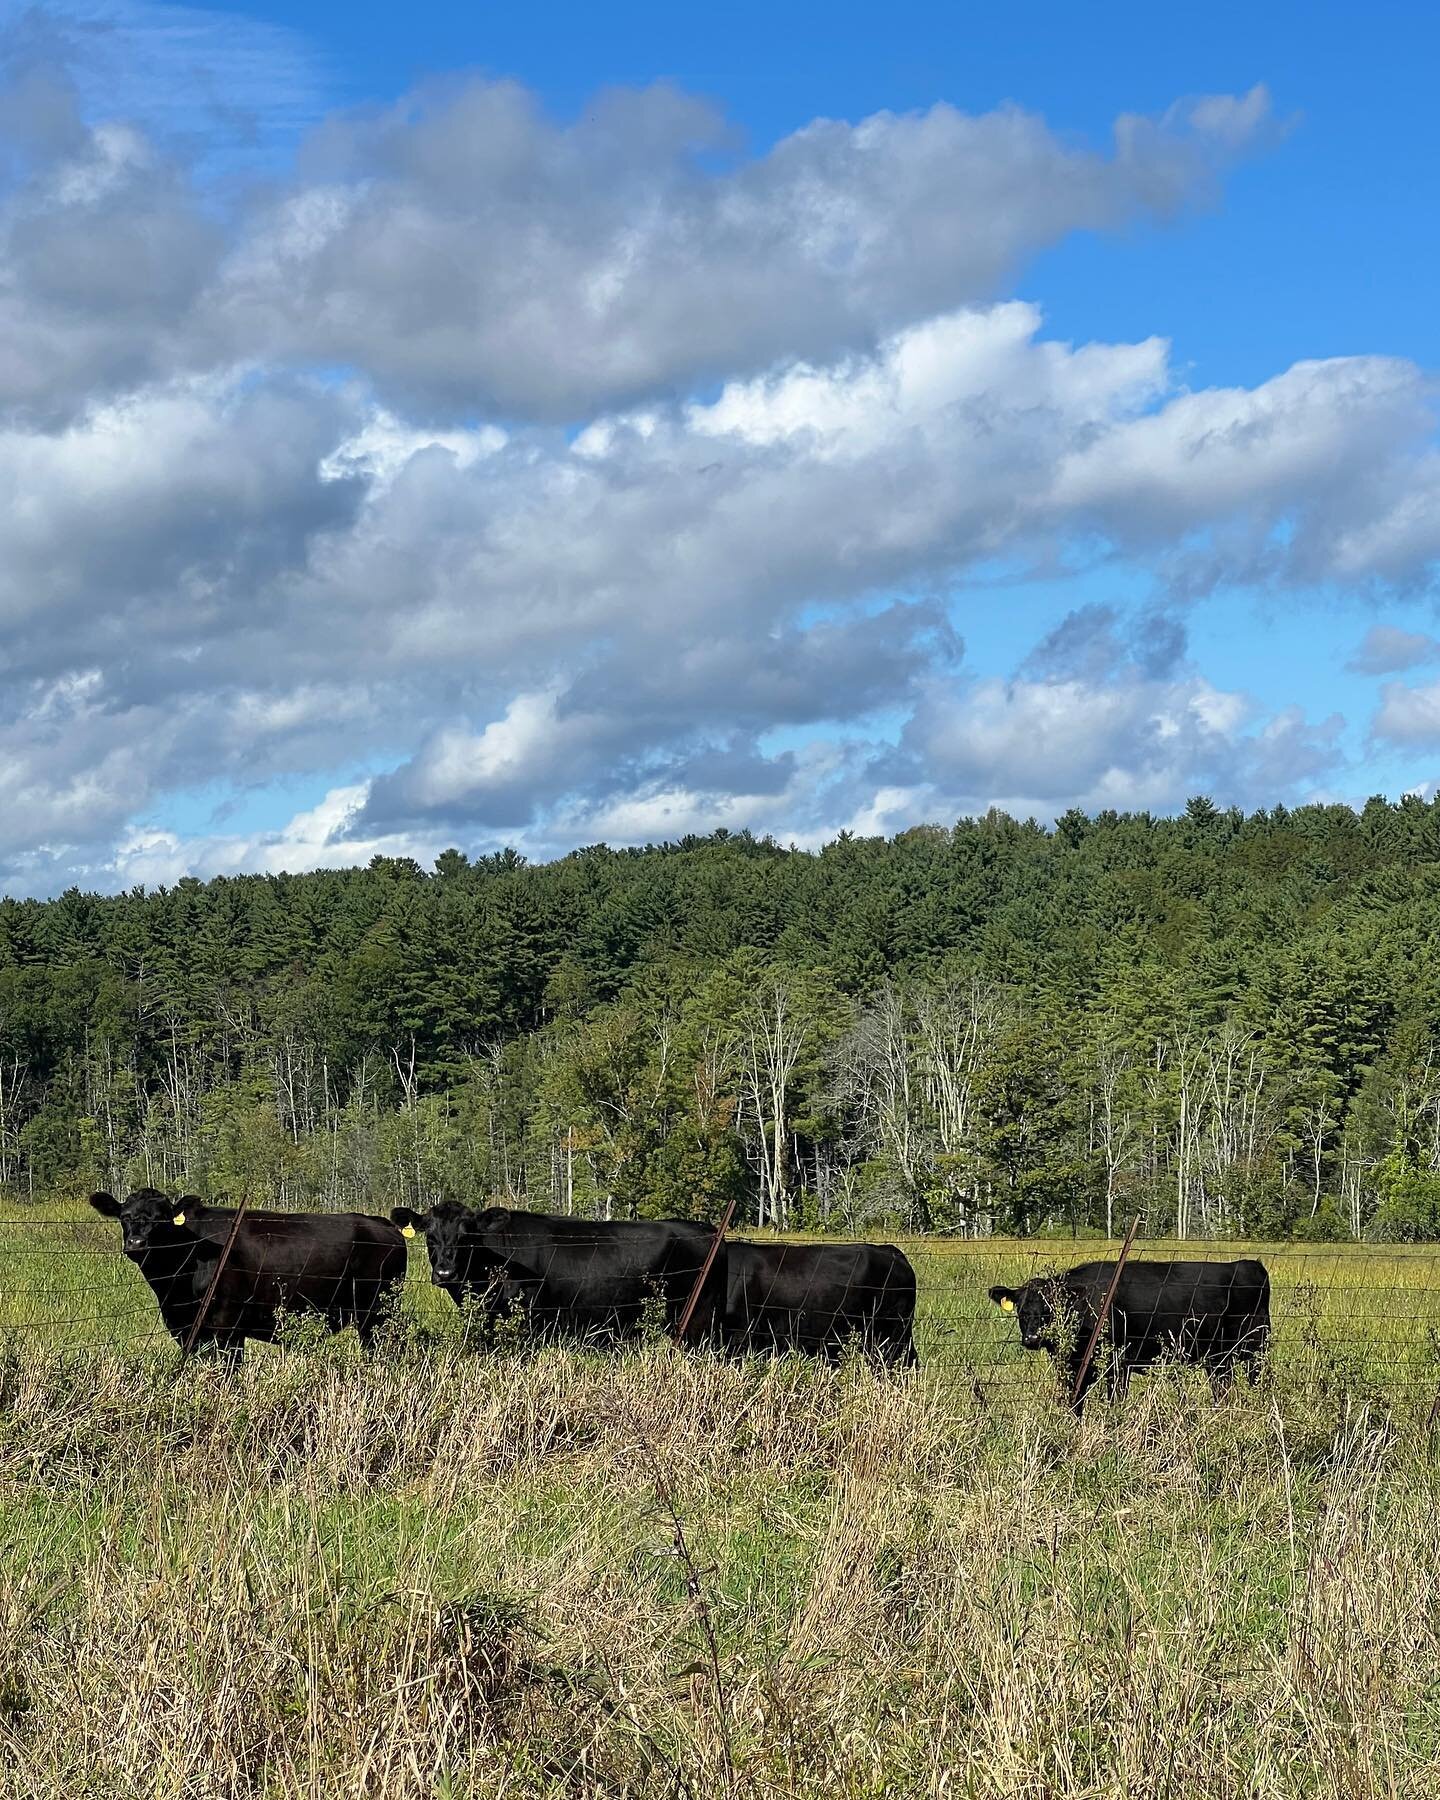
<box><xmin>391</xmin><ymin>1201</ymin><xmax>722</xmax><ymax>1341</ymax></box>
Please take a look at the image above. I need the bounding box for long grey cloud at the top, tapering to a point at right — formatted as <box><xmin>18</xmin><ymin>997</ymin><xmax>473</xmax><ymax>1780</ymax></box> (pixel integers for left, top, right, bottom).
<box><xmin>0</xmin><ymin>55</ymin><xmax>1271</xmax><ymax>419</ymax></box>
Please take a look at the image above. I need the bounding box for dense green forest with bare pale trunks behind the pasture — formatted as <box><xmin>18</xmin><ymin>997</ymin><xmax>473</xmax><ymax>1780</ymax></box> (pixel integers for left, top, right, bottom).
<box><xmin>0</xmin><ymin>796</ymin><xmax>1440</xmax><ymax>1240</ymax></box>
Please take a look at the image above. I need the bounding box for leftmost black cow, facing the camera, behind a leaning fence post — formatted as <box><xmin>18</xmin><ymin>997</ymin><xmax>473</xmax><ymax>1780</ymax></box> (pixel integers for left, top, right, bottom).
<box><xmin>90</xmin><ymin>1188</ymin><xmax>405</xmax><ymax>1361</ymax></box>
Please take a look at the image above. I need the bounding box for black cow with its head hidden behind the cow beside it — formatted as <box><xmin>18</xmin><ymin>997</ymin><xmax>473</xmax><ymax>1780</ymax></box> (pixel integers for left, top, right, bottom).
<box><xmin>722</xmin><ymin>1240</ymin><xmax>918</xmax><ymax>1366</ymax></box>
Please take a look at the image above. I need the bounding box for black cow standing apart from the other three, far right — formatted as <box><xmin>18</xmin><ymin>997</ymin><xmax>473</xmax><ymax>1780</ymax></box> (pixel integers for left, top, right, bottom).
<box><xmin>990</xmin><ymin>1256</ymin><xmax>1271</xmax><ymax>1413</ymax></box>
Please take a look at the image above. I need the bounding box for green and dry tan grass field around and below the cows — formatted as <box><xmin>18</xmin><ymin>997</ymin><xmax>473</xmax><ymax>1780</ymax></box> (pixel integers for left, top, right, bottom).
<box><xmin>0</xmin><ymin>1215</ymin><xmax>1440</xmax><ymax>1800</ymax></box>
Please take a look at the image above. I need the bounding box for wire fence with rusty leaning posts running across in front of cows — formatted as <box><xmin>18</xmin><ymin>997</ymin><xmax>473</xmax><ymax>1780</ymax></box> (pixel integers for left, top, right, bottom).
<box><xmin>0</xmin><ymin>1210</ymin><xmax>1440</xmax><ymax>1402</ymax></box>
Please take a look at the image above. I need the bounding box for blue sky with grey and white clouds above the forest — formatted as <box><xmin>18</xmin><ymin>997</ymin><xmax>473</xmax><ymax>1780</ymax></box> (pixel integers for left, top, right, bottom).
<box><xmin>0</xmin><ymin>0</ymin><xmax>1440</xmax><ymax>895</ymax></box>
